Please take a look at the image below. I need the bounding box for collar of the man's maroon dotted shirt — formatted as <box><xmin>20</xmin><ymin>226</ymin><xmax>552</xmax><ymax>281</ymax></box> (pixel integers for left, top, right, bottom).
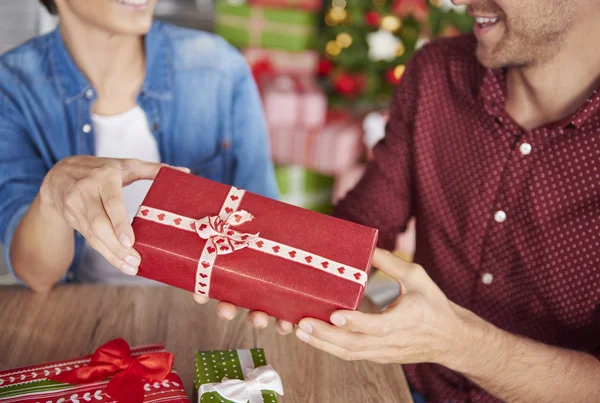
<box><xmin>481</xmin><ymin>69</ymin><xmax>600</xmax><ymax>129</ymax></box>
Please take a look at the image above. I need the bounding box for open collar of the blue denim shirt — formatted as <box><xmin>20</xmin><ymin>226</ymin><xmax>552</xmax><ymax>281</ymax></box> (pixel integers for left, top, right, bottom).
<box><xmin>49</xmin><ymin>21</ymin><xmax>173</xmax><ymax>103</ymax></box>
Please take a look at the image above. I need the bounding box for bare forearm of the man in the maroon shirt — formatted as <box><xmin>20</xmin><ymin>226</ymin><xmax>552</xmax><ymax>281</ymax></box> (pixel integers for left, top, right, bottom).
<box><xmin>447</xmin><ymin>308</ymin><xmax>600</xmax><ymax>403</ymax></box>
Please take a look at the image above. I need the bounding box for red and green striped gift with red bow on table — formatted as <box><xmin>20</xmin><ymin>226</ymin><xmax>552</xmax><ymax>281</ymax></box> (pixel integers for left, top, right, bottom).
<box><xmin>0</xmin><ymin>339</ymin><xmax>189</xmax><ymax>403</ymax></box>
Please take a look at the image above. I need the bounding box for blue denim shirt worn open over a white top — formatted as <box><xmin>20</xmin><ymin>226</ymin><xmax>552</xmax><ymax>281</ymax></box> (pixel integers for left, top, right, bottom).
<box><xmin>0</xmin><ymin>22</ymin><xmax>278</xmax><ymax>280</ymax></box>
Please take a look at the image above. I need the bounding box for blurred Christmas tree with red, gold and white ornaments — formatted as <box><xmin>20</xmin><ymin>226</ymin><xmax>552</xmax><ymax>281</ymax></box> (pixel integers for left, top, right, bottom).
<box><xmin>319</xmin><ymin>0</ymin><xmax>473</xmax><ymax>113</ymax></box>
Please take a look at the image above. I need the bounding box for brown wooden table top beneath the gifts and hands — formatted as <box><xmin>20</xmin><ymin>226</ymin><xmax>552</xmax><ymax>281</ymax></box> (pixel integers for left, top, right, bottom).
<box><xmin>0</xmin><ymin>285</ymin><xmax>412</xmax><ymax>403</ymax></box>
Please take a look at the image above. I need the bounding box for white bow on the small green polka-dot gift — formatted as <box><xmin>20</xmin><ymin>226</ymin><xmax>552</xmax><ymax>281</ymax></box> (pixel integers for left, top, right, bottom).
<box><xmin>198</xmin><ymin>365</ymin><xmax>283</xmax><ymax>403</ymax></box>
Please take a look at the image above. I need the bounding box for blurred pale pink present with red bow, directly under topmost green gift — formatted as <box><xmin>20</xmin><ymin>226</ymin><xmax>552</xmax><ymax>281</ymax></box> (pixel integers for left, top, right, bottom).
<box><xmin>243</xmin><ymin>48</ymin><xmax>319</xmax><ymax>84</ymax></box>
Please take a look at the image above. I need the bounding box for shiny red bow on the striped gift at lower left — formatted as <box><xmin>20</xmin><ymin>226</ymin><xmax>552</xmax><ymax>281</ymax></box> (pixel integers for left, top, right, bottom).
<box><xmin>49</xmin><ymin>339</ymin><xmax>173</xmax><ymax>403</ymax></box>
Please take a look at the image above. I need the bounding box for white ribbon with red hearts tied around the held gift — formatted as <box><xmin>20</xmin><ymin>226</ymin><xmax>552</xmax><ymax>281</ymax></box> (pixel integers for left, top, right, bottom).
<box><xmin>136</xmin><ymin>187</ymin><xmax>367</xmax><ymax>297</ymax></box>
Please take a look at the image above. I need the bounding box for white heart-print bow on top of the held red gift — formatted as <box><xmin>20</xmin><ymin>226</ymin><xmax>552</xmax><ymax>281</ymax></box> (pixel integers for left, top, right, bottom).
<box><xmin>196</xmin><ymin>210</ymin><xmax>259</xmax><ymax>255</ymax></box>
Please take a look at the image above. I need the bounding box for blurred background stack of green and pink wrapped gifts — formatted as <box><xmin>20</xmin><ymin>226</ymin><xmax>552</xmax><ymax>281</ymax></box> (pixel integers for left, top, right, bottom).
<box><xmin>215</xmin><ymin>0</ymin><xmax>364</xmax><ymax>213</ymax></box>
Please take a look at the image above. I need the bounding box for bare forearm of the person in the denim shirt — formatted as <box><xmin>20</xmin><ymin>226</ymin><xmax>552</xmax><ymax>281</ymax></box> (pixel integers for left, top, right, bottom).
<box><xmin>10</xmin><ymin>194</ymin><xmax>75</xmax><ymax>292</ymax></box>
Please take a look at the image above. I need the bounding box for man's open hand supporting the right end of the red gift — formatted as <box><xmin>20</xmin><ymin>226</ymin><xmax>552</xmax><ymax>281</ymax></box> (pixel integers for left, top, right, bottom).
<box><xmin>296</xmin><ymin>250</ymin><xmax>464</xmax><ymax>364</ymax></box>
